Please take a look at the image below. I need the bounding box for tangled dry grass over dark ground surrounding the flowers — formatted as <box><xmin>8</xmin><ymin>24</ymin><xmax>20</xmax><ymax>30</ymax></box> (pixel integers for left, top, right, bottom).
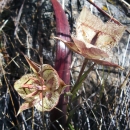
<box><xmin>0</xmin><ymin>0</ymin><xmax>130</xmax><ymax>130</ymax></box>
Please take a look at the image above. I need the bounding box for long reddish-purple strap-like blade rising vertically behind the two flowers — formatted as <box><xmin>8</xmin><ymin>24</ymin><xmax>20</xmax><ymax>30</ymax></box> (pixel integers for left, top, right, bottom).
<box><xmin>51</xmin><ymin>0</ymin><xmax>71</xmax><ymax>129</ymax></box>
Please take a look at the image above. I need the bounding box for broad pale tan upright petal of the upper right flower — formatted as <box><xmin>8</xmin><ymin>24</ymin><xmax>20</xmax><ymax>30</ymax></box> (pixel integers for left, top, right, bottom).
<box><xmin>76</xmin><ymin>7</ymin><xmax>126</xmax><ymax>49</ymax></box>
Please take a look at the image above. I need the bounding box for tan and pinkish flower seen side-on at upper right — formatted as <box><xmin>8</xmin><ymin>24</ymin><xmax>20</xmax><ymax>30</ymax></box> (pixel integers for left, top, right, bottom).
<box><xmin>54</xmin><ymin>7</ymin><xmax>126</xmax><ymax>68</ymax></box>
